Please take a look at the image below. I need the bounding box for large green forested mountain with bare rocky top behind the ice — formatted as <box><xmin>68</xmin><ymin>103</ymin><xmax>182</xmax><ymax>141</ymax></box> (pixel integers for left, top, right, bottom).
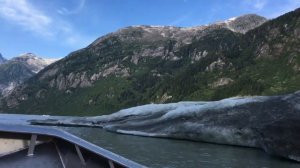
<box><xmin>0</xmin><ymin>9</ymin><xmax>300</xmax><ymax>115</ymax></box>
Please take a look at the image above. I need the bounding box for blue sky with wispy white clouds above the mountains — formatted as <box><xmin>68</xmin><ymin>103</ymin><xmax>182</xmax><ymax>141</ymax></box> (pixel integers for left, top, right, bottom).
<box><xmin>0</xmin><ymin>0</ymin><xmax>300</xmax><ymax>59</ymax></box>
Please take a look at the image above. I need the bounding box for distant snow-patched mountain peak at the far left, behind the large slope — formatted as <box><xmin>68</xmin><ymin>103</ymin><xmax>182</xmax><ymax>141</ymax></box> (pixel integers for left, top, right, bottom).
<box><xmin>0</xmin><ymin>53</ymin><xmax>55</xmax><ymax>96</ymax></box>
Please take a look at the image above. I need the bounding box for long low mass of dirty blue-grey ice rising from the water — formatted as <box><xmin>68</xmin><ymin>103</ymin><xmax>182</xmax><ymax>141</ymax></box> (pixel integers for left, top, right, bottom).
<box><xmin>31</xmin><ymin>91</ymin><xmax>300</xmax><ymax>161</ymax></box>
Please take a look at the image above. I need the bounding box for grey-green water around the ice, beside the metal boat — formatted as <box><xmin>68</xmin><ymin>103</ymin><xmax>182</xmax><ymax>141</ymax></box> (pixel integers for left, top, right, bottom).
<box><xmin>0</xmin><ymin>115</ymin><xmax>300</xmax><ymax>168</ymax></box>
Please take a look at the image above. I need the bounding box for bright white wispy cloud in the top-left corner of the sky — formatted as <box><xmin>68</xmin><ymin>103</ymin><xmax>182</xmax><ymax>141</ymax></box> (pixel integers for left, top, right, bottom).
<box><xmin>0</xmin><ymin>0</ymin><xmax>53</xmax><ymax>36</ymax></box>
